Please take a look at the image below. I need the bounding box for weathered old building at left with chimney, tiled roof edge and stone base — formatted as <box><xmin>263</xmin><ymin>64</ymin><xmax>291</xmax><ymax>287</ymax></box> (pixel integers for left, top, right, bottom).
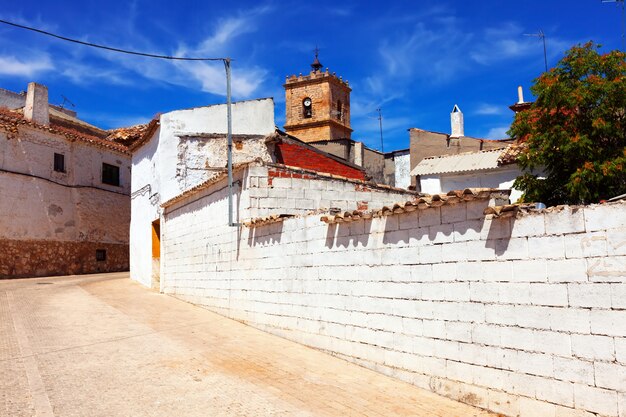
<box><xmin>0</xmin><ymin>83</ymin><xmax>130</xmax><ymax>278</ymax></box>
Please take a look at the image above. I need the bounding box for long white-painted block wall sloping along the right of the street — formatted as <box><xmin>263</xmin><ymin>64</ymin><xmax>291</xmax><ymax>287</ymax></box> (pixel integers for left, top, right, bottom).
<box><xmin>161</xmin><ymin>187</ymin><xmax>626</xmax><ymax>417</ymax></box>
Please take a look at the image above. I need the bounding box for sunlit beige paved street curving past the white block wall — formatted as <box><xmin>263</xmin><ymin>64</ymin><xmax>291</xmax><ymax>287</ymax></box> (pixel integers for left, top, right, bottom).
<box><xmin>0</xmin><ymin>273</ymin><xmax>489</xmax><ymax>417</ymax></box>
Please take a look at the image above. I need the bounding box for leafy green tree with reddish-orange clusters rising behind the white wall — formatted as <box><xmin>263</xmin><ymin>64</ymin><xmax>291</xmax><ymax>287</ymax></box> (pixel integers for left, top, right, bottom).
<box><xmin>509</xmin><ymin>42</ymin><xmax>626</xmax><ymax>205</ymax></box>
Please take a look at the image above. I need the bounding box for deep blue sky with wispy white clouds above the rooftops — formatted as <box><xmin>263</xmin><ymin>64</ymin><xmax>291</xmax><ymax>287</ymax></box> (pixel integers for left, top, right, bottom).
<box><xmin>0</xmin><ymin>0</ymin><xmax>621</xmax><ymax>151</ymax></box>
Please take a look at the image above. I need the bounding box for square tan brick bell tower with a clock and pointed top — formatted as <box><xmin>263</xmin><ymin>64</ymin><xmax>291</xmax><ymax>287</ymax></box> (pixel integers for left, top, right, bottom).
<box><xmin>283</xmin><ymin>48</ymin><xmax>352</xmax><ymax>142</ymax></box>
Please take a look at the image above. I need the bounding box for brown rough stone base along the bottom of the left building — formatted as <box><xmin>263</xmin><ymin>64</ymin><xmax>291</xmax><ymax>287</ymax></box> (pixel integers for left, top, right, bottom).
<box><xmin>0</xmin><ymin>239</ymin><xmax>128</xmax><ymax>279</ymax></box>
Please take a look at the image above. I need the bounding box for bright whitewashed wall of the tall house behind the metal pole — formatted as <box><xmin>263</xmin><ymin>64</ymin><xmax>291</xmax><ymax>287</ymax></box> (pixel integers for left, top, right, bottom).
<box><xmin>130</xmin><ymin>98</ymin><xmax>276</xmax><ymax>286</ymax></box>
